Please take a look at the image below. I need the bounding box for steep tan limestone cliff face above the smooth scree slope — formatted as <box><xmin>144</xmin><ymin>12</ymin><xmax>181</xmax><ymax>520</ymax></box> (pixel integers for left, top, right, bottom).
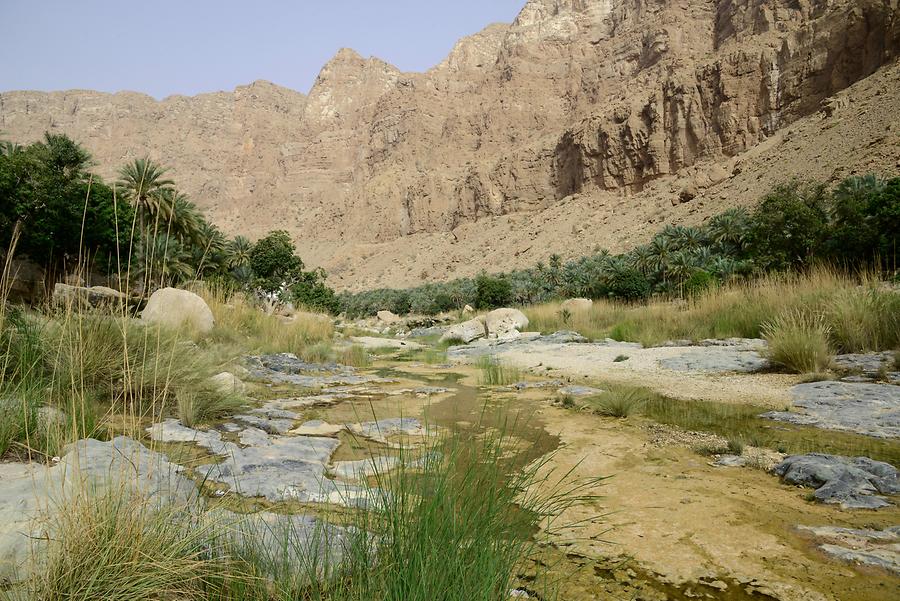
<box><xmin>0</xmin><ymin>0</ymin><xmax>900</xmax><ymax>276</ymax></box>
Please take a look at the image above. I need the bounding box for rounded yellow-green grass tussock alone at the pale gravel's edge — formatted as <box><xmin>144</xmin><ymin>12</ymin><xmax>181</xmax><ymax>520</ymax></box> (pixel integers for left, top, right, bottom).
<box><xmin>762</xmin><ymin>310</ymin><xmax>834</xmax><ymax>373</ymax></box>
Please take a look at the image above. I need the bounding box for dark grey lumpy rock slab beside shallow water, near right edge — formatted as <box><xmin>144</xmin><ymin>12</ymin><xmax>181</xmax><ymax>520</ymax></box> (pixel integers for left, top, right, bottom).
<box><xmin>772</xmin><ymin>453</ymin><xmax>900</xmax><ymax>509</ymax></box>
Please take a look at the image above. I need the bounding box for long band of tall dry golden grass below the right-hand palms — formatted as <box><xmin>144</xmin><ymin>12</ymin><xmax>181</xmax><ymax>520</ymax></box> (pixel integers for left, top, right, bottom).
<box><xmin>524</xmin><ymin>267</ymin><xmax>900</xmax><ymax>352</ymax></box>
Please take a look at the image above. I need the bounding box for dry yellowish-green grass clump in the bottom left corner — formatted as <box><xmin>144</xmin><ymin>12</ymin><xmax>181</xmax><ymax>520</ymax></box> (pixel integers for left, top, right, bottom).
<box><xmin>23</xmin><ymin>488</ymin><xmax>225</xmax><ymax>601</ymax></box>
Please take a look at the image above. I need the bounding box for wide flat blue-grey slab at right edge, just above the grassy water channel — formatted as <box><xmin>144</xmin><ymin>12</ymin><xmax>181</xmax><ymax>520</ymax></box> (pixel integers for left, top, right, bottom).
<box><xmin>761</xmin><ymin>382</ymin><xmax>900</xmax><ymax>438</ymax></box>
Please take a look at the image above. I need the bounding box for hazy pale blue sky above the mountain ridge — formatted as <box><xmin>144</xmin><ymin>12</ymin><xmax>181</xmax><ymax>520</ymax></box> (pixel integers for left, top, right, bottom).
<box><xmin>0</xmin><ymin>0</ymin><xmax>525</xmax><ymax>98</ymax></box>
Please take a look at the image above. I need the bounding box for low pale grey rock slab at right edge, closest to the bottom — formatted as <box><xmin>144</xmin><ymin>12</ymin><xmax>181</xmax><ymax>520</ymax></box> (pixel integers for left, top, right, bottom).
<box><xmin>799</xmin><ymin>526</ymin><xmax>900</xmax><ymax>576</ymax></box>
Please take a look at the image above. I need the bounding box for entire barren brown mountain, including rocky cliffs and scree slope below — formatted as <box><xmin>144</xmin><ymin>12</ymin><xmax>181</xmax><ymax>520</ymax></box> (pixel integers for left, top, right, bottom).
<box><xmin>0</xmin><ymin>0</ymin><xmax>900</xmax><ymax>289</ymax></box>
